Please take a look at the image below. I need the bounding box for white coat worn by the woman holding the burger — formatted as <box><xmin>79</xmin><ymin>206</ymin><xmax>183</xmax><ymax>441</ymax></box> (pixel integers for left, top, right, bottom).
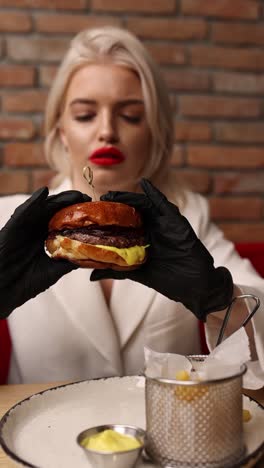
<box><xmin>0</xmin><ymin>182</ymin><xmax>264</xmax><ymax>383</ymax></box>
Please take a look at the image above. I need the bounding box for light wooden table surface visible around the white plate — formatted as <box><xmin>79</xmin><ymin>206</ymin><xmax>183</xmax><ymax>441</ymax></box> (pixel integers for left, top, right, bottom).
<box><xmin>0</xmin><ymin>382</ymin><xmax>264</xmax><ymax>468</ymax></box>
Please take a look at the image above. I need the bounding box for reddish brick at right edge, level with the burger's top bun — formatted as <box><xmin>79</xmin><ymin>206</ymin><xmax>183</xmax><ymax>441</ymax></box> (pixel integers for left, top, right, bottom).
<box><xmin>209</xmin><ymin>197</ymin><xmax>263</xmax><ymax>221</ymax></box>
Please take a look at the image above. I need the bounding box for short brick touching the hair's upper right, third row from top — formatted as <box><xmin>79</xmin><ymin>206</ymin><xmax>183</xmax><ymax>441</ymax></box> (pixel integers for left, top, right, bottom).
<box><xmin>145</xmin><ymin>42</ymin><xmax>186</xmax><ymax>65</ymax></box>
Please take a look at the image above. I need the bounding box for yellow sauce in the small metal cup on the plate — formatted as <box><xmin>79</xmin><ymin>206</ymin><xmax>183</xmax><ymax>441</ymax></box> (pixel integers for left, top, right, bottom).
<box><xmin>81</xmin><ymin>429</ymin><xmax>142</xmax><ymax>452</ymax></box>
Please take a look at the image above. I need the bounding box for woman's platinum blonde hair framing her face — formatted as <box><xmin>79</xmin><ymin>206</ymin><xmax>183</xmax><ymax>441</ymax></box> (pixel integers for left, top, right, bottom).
<box><xmin>45</xmin><ymin>26</ymin><xmax>177</xmax><ymax>195</ymax></box>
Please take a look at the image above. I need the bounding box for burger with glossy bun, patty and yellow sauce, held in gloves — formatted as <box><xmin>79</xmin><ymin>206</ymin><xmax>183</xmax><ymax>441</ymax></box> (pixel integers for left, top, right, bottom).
<box><xmin>45</xmin><ymin>201</ymin><xmax>147</xmax><ymax>270</ymax></box>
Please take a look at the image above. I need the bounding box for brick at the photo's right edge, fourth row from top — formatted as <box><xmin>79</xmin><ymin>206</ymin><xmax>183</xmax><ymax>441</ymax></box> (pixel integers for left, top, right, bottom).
<box><xmin>212</xmin><ymin>72</ymin><xmax>264</xmax><ymax>94</ymax></box>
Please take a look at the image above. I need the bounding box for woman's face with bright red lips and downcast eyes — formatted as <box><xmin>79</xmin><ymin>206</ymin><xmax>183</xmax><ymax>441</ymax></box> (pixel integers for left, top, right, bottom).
<box><xmin>60</xmin><ymin>64</ymin><xmax>151</xmax><ymax>195</ymax></box>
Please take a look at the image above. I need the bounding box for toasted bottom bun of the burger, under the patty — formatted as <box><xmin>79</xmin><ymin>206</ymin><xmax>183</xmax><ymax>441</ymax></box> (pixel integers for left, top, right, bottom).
<box><xmin>45</xmin><ymin>235</ymin><xmax>146</xmax><ymax>270</ymax></box>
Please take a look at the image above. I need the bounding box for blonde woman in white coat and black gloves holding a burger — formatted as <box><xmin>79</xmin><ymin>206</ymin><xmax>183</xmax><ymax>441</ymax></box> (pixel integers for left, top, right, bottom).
<box><xmin>0</xmin><ymin>27</ymin><xmax>264</xmax><ymax>383</ymax></box>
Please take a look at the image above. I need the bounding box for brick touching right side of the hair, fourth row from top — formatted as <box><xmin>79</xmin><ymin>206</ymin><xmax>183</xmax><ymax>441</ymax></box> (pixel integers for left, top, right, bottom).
<box><xmin>163</xmin><ymin>70</ymin><xmax>210</xmax><ymax>91</ymax></box>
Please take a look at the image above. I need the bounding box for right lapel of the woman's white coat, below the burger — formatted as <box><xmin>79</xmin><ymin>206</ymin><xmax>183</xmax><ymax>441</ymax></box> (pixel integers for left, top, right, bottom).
<box><xmin>110</xmin><ymin>280</ymin><xmax>156</xmax><ymax>349</ymax></box>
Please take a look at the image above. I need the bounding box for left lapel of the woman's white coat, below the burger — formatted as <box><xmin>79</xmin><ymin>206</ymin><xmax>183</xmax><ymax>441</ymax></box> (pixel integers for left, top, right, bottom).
<box><xmin>54</xmin><ymin>269</ymin><xmax>122</xmax><ymax>375</ymax></box>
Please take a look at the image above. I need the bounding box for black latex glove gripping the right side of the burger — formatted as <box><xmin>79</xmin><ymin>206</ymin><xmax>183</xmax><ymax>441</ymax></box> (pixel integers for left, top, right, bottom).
<box><xmin>91</xmin><ymin>179</ymin><xmax>233</xmax><ymax>321</ymax></box>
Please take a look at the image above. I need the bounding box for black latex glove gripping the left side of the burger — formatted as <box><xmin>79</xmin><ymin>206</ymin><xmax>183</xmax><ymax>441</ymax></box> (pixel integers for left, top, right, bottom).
<box><xmin>0</xmin><ymin>187</ymin><xmax>91</xmax><ymax>318</ymax></box>
